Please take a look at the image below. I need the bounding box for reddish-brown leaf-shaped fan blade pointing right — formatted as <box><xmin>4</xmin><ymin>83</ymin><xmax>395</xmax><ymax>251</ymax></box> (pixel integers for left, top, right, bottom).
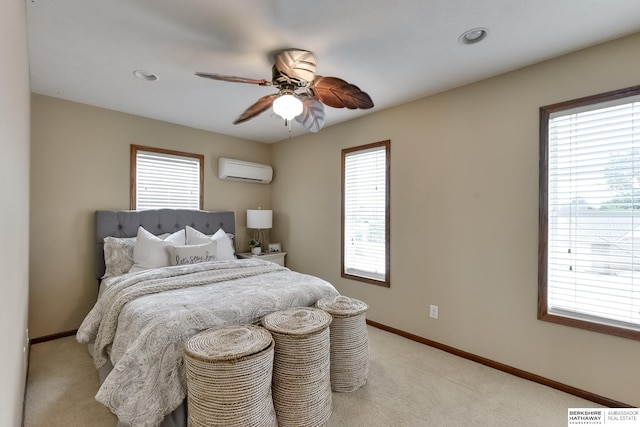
<box><xmin>311</xmin><ymin>76</ymin><xmax>373</xmax><ymax>110</ymax></box>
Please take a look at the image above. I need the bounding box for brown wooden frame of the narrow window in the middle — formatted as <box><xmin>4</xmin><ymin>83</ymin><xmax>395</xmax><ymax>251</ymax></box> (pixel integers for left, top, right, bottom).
<box><xmin>340</xmin><ymin>140</ymin><xmax>391</xmax><ymax>288</ymax></box>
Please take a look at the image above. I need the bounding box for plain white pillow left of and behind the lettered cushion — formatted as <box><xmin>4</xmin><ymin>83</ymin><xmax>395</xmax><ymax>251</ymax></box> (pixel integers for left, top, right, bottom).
<box><xmin>129</xmin><ymin>227</ymin><xmax>185</xmax><ymax>273</ymax></box>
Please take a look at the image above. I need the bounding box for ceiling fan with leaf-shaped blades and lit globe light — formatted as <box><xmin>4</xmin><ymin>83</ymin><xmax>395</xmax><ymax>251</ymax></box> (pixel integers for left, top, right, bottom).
<box><xmin>195</xmin><ymin>49</ymin><xmax>373</xmax><ymax>132</ymax></box>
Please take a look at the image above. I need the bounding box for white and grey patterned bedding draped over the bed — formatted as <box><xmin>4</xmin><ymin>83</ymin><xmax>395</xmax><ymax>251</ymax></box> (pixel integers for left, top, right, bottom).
<box><xmin>77</xmin><ymin>259</ymin><xmax>338</xmax><ymax>426</ymax></box>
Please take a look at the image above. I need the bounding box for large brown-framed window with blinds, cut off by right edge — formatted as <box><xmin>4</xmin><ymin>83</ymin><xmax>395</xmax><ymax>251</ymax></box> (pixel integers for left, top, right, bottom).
<box><xmin>538</xmin><ymin>86</ymin><xmax>640</xmax><ymax>340</ymax></box>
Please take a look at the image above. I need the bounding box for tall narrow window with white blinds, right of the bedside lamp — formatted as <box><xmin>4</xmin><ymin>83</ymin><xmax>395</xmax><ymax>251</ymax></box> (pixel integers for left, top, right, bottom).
<box><xmin>342</xmin><ymin>141</ymin><xmax>391</xmax><ymax>287</ymax></box>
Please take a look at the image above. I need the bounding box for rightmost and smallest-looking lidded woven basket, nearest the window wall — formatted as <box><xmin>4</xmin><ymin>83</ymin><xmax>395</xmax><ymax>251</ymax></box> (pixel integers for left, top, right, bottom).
<box><xmin>316</xmin><ymin>295</ymin><xmax>369</xmax><ymax>392</ymax></box>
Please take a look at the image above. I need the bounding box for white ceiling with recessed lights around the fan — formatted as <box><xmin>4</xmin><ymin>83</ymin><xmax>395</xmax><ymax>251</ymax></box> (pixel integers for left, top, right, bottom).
<box><xmin>25</xmin><ymin>0</ymin><xmax>640</xmax><ymax>142</ymax></box>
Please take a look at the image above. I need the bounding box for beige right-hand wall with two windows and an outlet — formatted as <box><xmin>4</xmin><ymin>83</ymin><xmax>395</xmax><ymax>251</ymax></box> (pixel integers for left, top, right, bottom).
<box><xmin>271</xmin><ymin>34</ymin><xmax>640</xmax><ymax>406</ymax></box>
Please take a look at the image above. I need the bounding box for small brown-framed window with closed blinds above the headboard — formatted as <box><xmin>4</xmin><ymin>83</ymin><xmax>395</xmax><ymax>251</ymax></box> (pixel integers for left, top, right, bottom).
<box><xmin>131</xmin><ymin>145</ymin><xmax>204</xmax><ymax>209</ymax></box>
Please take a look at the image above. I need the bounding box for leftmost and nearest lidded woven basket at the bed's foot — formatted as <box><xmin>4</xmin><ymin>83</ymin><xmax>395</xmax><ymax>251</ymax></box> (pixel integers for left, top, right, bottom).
<box><xmin>184</xmin><ymin>325</ymin><xmax>278</xmax><ymax>427</ymax></box>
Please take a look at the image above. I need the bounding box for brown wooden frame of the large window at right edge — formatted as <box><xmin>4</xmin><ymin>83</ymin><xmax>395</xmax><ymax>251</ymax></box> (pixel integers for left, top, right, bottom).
<box><xmin>538</xmin><ymin>86</ymin><xmax>640</xmax><ymax>340</ymax></box>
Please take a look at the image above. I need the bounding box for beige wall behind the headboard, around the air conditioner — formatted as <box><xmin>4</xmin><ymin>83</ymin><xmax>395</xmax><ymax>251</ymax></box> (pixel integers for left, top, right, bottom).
<box><xmin>29</xmin><ymin>95</ymin><xmax>270</xmax><ymax>338</ymax></box>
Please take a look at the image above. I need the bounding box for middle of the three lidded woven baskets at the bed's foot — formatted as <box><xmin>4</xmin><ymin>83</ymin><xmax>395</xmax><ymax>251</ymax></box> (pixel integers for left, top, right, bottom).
<box><xmin>262</xmin><ymin>307</ymin><xmax>332</xmax><ymax>427</ymax></box>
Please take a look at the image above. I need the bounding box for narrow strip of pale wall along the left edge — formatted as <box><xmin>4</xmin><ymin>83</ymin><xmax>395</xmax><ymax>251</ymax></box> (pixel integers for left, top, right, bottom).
<box><xmin>0</xmin><ymin>0</ymin><xmax>29</xmax><ymax>427</ymax></box>
